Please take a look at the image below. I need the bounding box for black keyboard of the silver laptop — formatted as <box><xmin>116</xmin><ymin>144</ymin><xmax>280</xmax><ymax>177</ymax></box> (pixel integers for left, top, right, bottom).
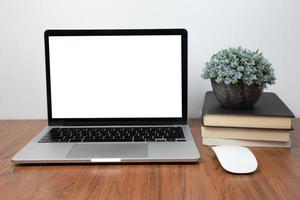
<box><xmin>39</xmin><ymin>127</ymin><xmax>185</xmax><ymax>143</ymax></box>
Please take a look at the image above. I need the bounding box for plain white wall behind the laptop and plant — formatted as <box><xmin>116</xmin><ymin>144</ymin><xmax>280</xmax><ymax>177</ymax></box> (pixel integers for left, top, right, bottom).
<box><xmin>0</xmin><ymin>0</ymin><xmax>300</xmax><ymax>119</ymax></box>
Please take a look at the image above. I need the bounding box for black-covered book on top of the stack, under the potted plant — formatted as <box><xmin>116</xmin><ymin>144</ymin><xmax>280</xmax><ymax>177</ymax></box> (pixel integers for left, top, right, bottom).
<box><xmin>202</xmin><ymin>91</ymin><xmax>294</xmax><ymax>130</ymax></box>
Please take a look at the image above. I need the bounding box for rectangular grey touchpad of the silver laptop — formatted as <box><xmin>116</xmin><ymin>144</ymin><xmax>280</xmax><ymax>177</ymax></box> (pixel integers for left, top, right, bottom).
<box><xmin>66</xmin><ymin>143</ymin><xmax>148</xmax><ymax>158</ymax></box>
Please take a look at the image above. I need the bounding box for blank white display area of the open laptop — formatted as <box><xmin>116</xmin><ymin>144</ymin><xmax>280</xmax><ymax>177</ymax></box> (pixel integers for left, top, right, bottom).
<box><xmin>49</xmin><ymin>35</ymin><xmax>182</xmax><ymax>118</ymax></box>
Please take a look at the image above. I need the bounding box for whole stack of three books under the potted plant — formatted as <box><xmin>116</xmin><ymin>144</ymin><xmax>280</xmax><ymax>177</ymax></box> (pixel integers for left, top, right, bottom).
<box><xmin>201</xmin><ymin>91</ymin><xmax>294</xmax><ymax>147</ymax></box>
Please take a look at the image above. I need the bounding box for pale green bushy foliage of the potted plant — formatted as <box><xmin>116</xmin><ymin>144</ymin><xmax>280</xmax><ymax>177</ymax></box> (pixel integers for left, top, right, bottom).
<box><xmin>202</xmin><ymin>47</ymin><xmax>276</xmax><ymax>87</ymax></box>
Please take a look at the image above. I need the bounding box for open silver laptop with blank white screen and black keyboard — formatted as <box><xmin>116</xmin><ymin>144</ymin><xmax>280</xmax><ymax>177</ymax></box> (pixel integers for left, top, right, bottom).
<box><xmin>12</xmin><ymin>29</ymin><xmax>200</xmax><ymax>164</ymax></box>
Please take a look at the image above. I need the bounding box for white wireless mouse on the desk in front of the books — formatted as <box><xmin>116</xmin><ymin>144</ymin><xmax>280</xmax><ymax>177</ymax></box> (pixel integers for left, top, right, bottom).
<box><xmin>212</xmin><ymin>145</ymin><xmax>258</xmax><ymax>174</ymax></box>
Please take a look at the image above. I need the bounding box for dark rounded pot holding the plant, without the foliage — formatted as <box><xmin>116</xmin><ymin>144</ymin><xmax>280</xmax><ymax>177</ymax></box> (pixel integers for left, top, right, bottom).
<box><xmin>211</xmin><ymin>79</ymin><xmax>264</xmax><ymax>108</ymax></box>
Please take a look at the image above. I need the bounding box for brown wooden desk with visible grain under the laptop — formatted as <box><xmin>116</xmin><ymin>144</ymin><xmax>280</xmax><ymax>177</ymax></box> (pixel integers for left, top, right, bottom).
<box><xmin>0</xmin><ymin>119</ymin><xmax>300</xmax><ymax>200</ymax></box>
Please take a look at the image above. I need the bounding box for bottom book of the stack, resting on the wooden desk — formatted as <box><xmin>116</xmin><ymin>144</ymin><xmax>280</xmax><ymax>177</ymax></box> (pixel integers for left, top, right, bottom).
<box><xmin>202</xmin><ymin>138</ymin><xmax>292</xmax><ymax>148</ymax></box>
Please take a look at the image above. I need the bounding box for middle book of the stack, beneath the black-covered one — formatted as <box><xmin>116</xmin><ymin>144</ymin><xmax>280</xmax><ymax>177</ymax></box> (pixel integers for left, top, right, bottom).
<box><xmin>201</xmin><ymin>126</ymin><xmax>291</xmax><ymax>142</ymax></box>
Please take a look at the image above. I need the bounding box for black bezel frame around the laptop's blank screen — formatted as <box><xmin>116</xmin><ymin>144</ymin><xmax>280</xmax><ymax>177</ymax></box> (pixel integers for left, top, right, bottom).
<box><xmin>44</xmin><ymin>29</ymin><xmax>188</xmax><ymax>126</ymax></box>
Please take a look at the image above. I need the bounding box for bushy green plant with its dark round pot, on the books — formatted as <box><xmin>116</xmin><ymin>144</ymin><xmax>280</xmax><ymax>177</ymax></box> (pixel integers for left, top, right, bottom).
<box><xmin>202</xmin><ymin>47</ymin><xmax>275</xmax><ymax>108</ymax></box>
